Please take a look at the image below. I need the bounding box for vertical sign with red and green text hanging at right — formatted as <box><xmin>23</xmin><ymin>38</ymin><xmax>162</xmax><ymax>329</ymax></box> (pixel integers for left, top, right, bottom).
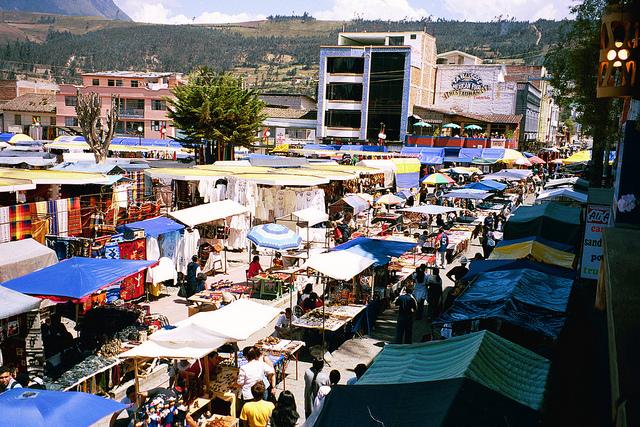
<box><xmin>580</xmin><ymin>205</ymin><xmax>611</xmax><ymax>280</ymax></box>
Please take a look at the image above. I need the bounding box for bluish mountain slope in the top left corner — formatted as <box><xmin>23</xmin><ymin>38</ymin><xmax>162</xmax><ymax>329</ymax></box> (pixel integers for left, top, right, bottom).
<box><xmin>0</xmin><ymin>0</ymin><xmax>131</xmax><ymax>21</ymax></box>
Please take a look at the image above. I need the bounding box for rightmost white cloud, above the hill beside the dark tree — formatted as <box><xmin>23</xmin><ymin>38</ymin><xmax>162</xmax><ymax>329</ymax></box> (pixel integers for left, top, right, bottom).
<box><xmin>444</xmin><ymin>0</ymin><xmax>575</xmax><ymax>21</ymax></box>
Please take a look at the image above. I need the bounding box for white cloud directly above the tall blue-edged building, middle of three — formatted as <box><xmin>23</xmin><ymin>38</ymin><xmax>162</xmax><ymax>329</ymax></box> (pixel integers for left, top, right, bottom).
<box><xmin>312</xmin><ymin>0</ymin><xmax>429</xmax><ymax>21</ymax></box>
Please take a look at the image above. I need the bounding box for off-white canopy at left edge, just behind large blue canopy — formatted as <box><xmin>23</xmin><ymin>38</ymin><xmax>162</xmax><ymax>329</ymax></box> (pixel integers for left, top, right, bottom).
<box><xmin>0</xmin><ymin>239</ymin><xmax>58</xmax><ymax>282</ymax></box>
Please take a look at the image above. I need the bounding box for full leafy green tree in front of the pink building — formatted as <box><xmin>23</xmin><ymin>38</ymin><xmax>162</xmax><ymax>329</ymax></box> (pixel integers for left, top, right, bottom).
<box><xmin>167</xmin><ymin>68</ymin><xmax>266</xmax><ymax>162</ymax></box>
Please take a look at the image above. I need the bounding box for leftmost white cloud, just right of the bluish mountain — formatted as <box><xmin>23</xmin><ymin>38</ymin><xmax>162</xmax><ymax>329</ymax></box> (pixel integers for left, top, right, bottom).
<box><xmin>117</xmin><ymin>0</ymin><xmax>266</xmax><ymax>25</ymax></box>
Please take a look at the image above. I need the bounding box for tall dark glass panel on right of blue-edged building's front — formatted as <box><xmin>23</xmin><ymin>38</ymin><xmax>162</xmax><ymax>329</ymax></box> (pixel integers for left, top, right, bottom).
<box><xmin>367</xmin><ymin>52</ymin><xmax>406</xmax><ymax>141</ymax></box>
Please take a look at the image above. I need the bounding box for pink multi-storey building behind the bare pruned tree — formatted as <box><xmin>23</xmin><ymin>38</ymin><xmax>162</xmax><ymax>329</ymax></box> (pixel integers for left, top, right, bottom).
<box><xmin>56</xmin><ymin>71</ymin><xmax>183</xmax><ymax>139</ymax></box>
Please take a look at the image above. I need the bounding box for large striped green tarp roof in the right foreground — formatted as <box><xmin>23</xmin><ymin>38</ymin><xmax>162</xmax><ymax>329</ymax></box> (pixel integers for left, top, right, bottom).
<box><xmin>358</xmin><ymin>331</ymin><xmax>550</xmax><ymax>410</ymax></box>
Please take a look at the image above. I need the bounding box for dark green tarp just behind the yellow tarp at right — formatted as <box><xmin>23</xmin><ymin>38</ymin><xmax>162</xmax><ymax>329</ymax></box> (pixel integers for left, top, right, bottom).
<box><xmin>504</xmin><ymin>203</ymin><xmax>580</xmax><ymax>245</ymax></box>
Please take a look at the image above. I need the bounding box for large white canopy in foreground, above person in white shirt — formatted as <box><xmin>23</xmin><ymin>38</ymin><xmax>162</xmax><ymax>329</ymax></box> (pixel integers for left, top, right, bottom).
<box><xmin>120</xmin><ymin>299</ymin><xmax>280</xmax><ymax>359</ymax></box>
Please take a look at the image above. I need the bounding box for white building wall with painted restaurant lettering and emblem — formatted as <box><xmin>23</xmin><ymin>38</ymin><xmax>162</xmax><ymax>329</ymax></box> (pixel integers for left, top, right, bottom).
<box><xmin>434</xmin><ymin>65</ymin><xmax>517</xmax><ymax>114</ymax></box>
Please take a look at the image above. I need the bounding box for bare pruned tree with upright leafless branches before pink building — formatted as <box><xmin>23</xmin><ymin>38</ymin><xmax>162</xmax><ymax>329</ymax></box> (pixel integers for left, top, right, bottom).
<box><xmin>76</xmin><ymin>90</ymin><xmax>119</xmax><ymax>164</ymax></box>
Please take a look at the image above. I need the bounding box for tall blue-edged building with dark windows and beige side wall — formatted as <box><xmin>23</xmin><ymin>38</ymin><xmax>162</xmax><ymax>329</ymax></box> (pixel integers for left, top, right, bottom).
<box><xmin>316</xmin><ymin>31</ymin><xmax>436</xmax><ymax>142</ymax></box>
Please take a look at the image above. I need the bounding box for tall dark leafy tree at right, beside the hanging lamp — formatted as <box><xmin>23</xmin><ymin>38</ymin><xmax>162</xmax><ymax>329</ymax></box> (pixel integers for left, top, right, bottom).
<box><xmin>545</xmin><ymin>0</ymin><xmax>620</xmax><ymax>187</ymax></box>
